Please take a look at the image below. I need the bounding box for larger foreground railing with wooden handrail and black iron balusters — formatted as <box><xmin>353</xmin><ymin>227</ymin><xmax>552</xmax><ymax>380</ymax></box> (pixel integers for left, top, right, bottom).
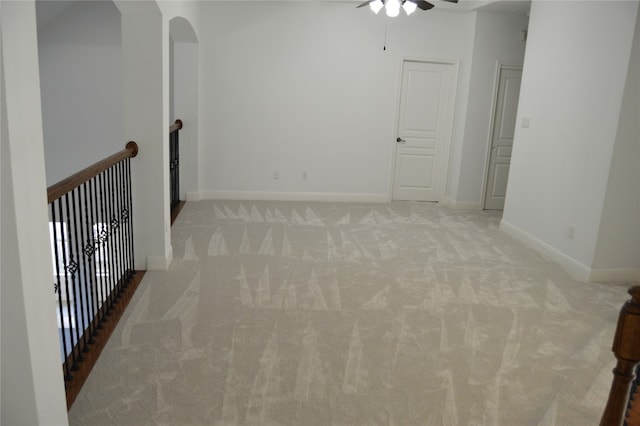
<box><xmin>47</xmin><ymin>142</ymin><xmax>143</xmax><ymax>407</ymax></box>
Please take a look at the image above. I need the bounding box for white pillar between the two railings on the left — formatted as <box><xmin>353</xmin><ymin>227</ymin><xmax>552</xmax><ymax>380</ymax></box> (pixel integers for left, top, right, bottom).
<box><xmin>116</xmin><ymin>0</ymin><xmax>172</xmax><ymax>269</ymax></box>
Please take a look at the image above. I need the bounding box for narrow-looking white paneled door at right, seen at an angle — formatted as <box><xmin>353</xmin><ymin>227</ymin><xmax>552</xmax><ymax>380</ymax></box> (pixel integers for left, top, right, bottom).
<box><xmin>484</xmin><ymin>66</ymin><xmax>522</xmax><ymax>210</ymax></box>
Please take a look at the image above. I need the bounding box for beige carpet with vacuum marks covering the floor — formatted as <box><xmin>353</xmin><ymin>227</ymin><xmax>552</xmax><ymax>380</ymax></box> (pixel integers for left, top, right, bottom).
<box><xmin>70</xmin><ymin>201</ymin><xmax>628</xmax><ymax>426</ymax></box>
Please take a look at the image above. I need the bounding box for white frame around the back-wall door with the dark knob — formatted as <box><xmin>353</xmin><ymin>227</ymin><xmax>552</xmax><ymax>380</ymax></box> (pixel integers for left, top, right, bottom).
<box><xmin>387</xmin><ymin>56</ymin><xmax>460</xmax><ymax>204</ymax></box>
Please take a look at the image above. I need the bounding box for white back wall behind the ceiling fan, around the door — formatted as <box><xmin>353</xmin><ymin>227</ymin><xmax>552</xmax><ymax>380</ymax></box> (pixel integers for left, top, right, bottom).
<box><xmin>200</xmin><ymin>2</ymin><xmax>475</xmax><ymax>199</ymax></box>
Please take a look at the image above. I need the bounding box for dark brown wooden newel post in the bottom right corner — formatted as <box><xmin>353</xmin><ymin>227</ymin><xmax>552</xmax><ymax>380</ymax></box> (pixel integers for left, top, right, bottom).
<box><xmin>600</xmin><ymin>286</ymin><xmax>640</xmax><ymax>426</ymax></box>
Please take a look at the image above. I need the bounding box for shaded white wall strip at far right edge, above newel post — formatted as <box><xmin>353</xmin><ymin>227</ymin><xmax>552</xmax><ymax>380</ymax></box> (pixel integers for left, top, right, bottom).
<box><xmin>592</xmin><ymin>5</ymin><xmax>640</xmax><ymax>280</ymax></box>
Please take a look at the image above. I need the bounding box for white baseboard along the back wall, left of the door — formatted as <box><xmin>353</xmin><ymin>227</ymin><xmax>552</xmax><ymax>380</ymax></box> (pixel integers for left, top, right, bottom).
<box><xmin>198</xmin><ymin>191</ymin><xmax>389</xmax><ymax>203</ymax></box>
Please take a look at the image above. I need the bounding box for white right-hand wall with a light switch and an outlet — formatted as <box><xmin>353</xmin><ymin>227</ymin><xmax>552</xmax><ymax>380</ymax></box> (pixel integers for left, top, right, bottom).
<box><xmin>503</xmin><ymin>1</ymin><xmax>638</xmax><ymax>278</ymax></box>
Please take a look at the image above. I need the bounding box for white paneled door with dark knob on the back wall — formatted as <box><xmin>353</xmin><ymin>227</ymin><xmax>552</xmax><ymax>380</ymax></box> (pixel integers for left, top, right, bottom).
<box><xmin>392</xmin><ymin>61</ymin><xmax>454</xmax><ymax>201</ymax></box>
